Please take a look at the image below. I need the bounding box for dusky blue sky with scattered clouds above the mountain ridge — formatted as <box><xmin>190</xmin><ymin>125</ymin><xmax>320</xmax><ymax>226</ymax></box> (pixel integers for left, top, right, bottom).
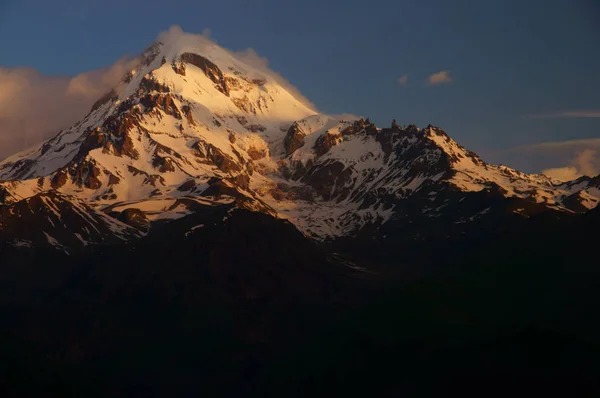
<box><xmin>0</xmin><ymin>0</ymin><xmax>600</xmax><ymax>178</ymax></box>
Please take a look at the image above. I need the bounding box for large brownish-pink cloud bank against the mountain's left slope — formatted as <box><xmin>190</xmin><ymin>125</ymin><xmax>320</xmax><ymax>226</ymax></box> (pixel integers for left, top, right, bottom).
<box><xmin>0</xmin><ymin>58</ymin><xmax>137</xmax><ymax>160</ymax></box>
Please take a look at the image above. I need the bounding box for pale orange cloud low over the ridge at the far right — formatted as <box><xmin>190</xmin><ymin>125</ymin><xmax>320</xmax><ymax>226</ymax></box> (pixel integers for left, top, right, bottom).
<box><xmin>514</xmin><ymin>138</ymin><xmax>600</xmax><ymax>181</ymax></box>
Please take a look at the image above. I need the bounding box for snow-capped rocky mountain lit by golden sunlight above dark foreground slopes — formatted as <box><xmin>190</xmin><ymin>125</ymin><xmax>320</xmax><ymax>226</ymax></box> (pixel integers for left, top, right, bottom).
<box><xmin>0</xmin><ymin>27</ymin><xmax>600</xmax><ymax>249</ymax></box>
